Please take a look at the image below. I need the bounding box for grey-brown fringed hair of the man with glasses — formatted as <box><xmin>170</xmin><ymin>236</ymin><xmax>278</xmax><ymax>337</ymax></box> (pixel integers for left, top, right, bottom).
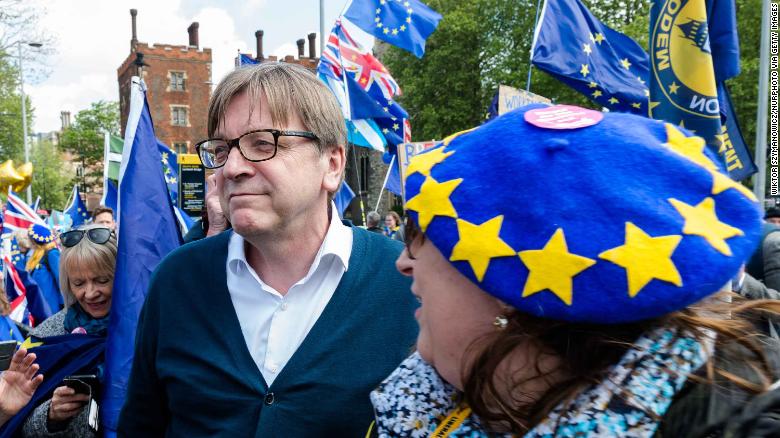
<box><xmin>208</xmin><ymin>62</ymin><xmax>347</xmax><ymax>152</ymax></box>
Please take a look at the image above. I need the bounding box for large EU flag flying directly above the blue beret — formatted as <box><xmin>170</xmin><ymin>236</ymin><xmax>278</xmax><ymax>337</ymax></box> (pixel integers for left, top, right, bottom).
<box><xmin>531</xmin><ymin>0</ymin><xmax>649</xmax><ymax>115</ymax></box>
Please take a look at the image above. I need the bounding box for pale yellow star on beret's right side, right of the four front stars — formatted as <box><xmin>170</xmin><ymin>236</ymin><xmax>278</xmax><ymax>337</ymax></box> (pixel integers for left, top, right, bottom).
<box><xmin>669</xmin><ymin>198</ymin><xmax>745</xmax><ymax>256</ymax></box>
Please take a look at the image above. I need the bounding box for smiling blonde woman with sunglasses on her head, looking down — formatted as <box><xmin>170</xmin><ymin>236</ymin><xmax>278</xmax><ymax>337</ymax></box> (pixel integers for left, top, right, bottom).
<box><xmin>23</xmin><ymin>224</ymin><xmax>117</xmax><ymax>438</ymax></box>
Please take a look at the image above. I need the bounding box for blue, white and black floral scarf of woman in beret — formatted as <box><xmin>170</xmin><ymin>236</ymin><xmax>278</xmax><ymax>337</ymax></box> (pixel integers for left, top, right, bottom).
<box><xmin>371</xmin><ymin>328</ymin><xmax>713</xmax><ymax>438</ymax></box>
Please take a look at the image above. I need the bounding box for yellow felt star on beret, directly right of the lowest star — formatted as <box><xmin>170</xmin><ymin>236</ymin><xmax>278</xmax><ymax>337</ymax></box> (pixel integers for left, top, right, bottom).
<box><xmin>599</xmin><ymin>222</ymin><xmax>682</xmax><ymax>298</ymax></box>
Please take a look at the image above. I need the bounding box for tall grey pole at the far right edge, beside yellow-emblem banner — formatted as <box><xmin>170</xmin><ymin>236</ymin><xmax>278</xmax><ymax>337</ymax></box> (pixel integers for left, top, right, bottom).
<box><xmin>753</xmin><ymin>0</ymin><xmax>769</xmax><ymax>205</ymax></box>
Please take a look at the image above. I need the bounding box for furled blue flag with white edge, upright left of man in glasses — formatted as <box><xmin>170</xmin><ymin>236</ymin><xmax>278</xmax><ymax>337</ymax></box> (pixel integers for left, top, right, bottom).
<box><xmin>100</xmin><ymin>77</ymin><xmax>181</xmax><ymax>432</ymax></box>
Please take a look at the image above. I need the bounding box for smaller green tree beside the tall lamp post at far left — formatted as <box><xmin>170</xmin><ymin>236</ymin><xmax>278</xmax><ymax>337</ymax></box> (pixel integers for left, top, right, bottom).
<box><xmin>30</xmin><ymin>140</ymin><xmax>73</xmax><ymax>210</ymax></box>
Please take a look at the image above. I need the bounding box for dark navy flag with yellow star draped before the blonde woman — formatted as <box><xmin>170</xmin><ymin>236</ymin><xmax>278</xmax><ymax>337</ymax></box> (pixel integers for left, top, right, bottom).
<box><xmin>0</xmin><ymin>334</ymin><xmax>106</xmax><ymax>438</ymax></box>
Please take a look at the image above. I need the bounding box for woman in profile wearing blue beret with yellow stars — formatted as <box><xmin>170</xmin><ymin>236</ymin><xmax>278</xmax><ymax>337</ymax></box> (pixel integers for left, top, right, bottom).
<box><xmin>371</xmin><ymin>105</ymin><xmax>780</xmax><ymax>437</ymax></box>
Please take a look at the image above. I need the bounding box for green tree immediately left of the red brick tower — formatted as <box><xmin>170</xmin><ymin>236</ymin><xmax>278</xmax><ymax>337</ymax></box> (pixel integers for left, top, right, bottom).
<box><xmin>60</xmin><ymin>101</ymin><xmax>119</xmax><ymax>191</ymax></box>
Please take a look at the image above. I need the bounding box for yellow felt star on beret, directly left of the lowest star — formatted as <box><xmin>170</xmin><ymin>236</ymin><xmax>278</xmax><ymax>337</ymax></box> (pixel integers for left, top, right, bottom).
<box><xmin>450</xmin><ymin>215</ymin><xmax>516</xmax><ymax>281</ymax></box>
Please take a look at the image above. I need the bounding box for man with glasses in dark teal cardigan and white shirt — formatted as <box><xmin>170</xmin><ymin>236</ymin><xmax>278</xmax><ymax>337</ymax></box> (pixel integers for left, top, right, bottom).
<box><xmin>119</xmin><ymin>63</ymin><xmax>417</xmax><ymax>437</ymax></box>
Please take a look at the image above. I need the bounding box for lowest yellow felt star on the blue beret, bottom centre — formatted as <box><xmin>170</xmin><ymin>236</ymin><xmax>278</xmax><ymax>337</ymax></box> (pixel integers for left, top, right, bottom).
<box><xmin>518</xmin><ymin>228</ymin><xmax>596</xmax><ymax>306</ymax></box>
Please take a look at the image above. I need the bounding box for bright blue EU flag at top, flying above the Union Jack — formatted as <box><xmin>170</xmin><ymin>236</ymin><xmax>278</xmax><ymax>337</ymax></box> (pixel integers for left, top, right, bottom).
<box><xmin>344</xmin><ymin>0</ymin><xmax>441</xmax><ymax>58</ymax></box>
